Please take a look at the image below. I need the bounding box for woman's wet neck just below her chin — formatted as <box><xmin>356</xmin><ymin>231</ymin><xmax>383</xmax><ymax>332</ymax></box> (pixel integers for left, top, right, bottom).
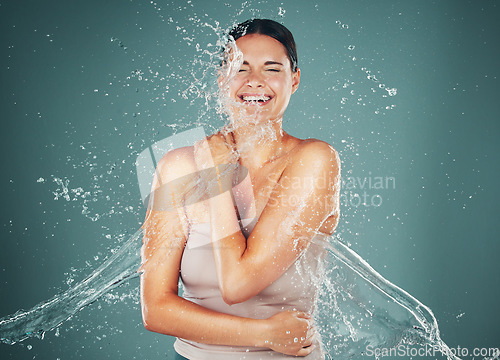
<box><xmin>232</xmin><ymin>119</ymin><xmax>290</xmax><ymax>171</ymax></box>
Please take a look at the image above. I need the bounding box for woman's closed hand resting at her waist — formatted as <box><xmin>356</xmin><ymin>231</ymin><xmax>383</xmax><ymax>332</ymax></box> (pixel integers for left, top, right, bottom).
<box><xmin>264</xmin><ymin>310</ymin><xmax>316</xmax><ymax>356</ymax></box>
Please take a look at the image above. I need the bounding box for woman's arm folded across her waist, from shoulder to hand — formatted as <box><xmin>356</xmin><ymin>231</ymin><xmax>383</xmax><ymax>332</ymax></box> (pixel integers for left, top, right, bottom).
<box><xmin>140</xmin><ymin>148</ymin><xmax>314</xmax><ymax>356</ymax></box>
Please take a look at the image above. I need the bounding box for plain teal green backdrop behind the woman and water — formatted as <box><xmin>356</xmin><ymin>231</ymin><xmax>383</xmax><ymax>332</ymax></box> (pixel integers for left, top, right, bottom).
<box><xmin>0</xmin><ymin>0</ymin><xmax>500</xmax><ymax>359</ymax></box>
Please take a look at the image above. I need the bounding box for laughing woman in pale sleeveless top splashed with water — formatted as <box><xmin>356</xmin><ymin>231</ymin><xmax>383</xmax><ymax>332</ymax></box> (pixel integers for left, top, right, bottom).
<box><xmin>141</xmin><ymin>19</ymin><xmax>340</xmax><ymax>359</ymax></box>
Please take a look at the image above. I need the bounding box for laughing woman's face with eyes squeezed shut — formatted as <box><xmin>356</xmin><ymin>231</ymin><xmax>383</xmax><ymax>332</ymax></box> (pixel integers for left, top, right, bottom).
<box><xmin>221</xmin><ymin>34</ymin><xmax>300</xmax><ymax>121</ymax></box>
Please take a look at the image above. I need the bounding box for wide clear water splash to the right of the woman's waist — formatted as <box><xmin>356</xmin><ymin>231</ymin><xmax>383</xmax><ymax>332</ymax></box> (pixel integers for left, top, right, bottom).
<box><xmin>317</xmin><ymin>236</ymin><xmax>459</xmax><ymax>360</ymax></box>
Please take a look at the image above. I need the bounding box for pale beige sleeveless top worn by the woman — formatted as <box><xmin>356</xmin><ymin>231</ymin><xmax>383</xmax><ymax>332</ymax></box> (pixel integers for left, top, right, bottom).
<box><xmin>174</xmin><ymin>218</ymin><xmax>329</xmax><ymax>360</ymax></box>
